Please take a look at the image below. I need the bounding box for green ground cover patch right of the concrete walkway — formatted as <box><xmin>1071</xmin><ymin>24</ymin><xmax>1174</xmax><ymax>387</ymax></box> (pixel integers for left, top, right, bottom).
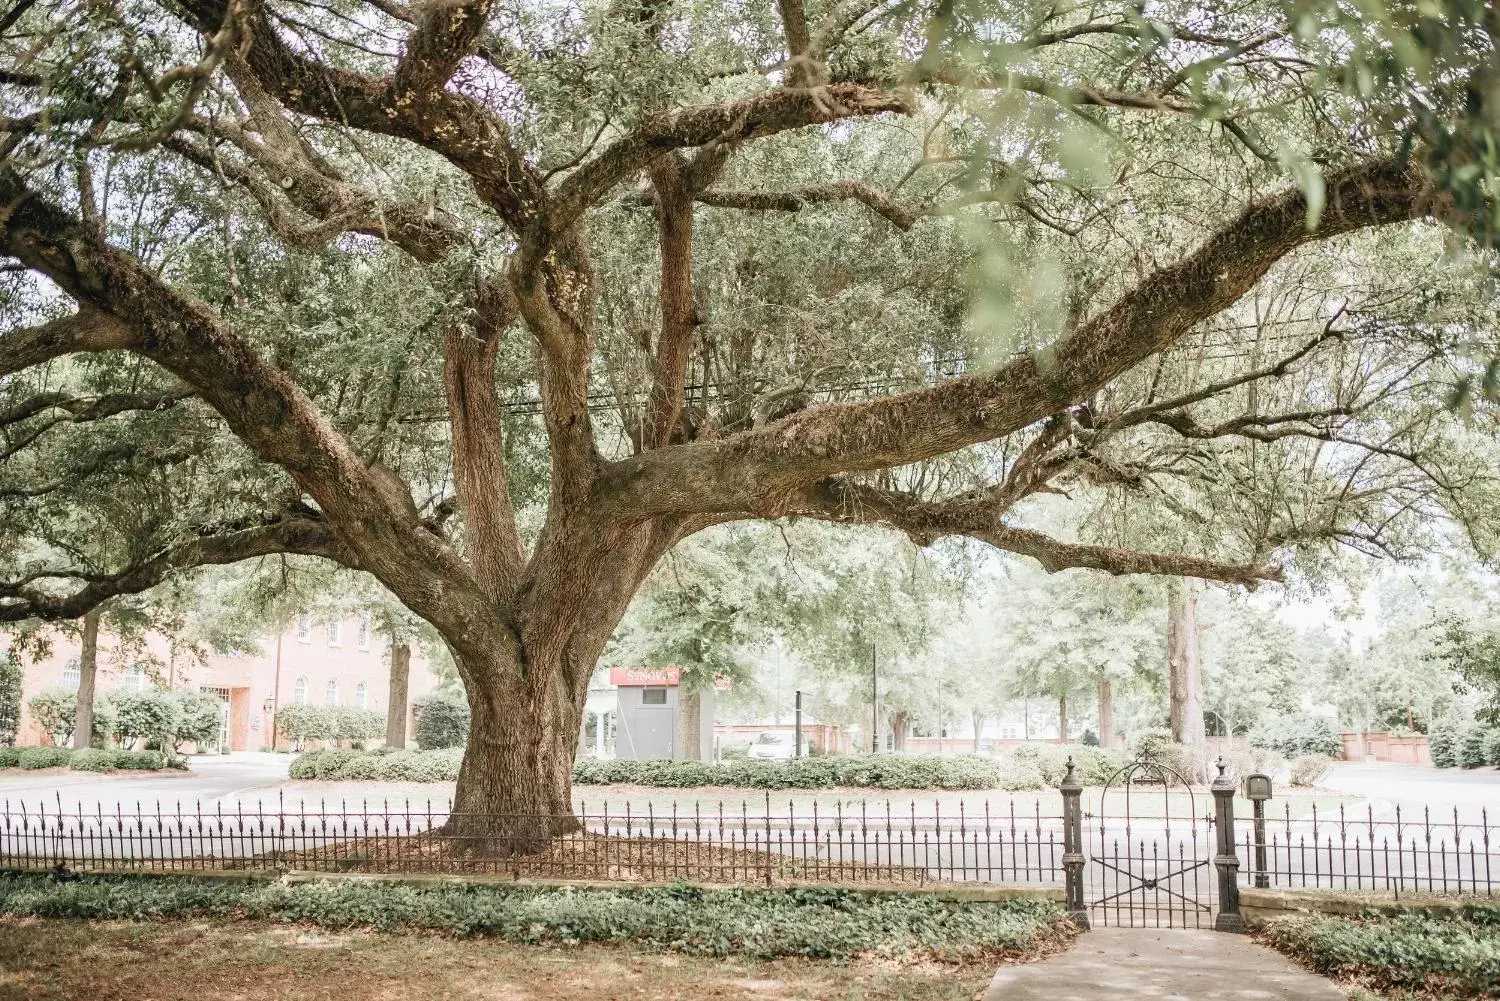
<box><xmin>1262</xmin><ymin>905</ymin><xmax>1500</xmax><ymax>998</ymax></box>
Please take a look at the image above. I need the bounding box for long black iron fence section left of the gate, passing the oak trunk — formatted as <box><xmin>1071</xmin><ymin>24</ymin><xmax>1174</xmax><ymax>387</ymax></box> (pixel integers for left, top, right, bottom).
<box><xmin>0</xmin><ymin>795</ymin><xmax>1062</xmax><ymax>885</ymax></box>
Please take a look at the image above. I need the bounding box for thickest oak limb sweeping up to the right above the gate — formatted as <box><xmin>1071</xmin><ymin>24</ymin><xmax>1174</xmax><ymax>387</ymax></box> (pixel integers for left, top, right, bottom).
<box><xmin>605</xmin><ymin>159</ymin><xmax>1446</xmax><ymax>518</ymax></box>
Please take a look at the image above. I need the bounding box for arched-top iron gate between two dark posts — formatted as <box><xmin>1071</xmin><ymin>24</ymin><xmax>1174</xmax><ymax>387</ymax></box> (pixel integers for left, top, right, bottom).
<box><xmin>1083</xmin><ymin>761</ymin><xmax>1217</xmax><ymax>927</ymax></box>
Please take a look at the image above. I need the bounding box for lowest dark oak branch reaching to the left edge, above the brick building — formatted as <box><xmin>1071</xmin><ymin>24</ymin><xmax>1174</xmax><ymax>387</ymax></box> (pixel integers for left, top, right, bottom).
<box><xmin>0</xmin><ymin>515</ymin><xmax>359</xmax><ymax>621</ymax></box>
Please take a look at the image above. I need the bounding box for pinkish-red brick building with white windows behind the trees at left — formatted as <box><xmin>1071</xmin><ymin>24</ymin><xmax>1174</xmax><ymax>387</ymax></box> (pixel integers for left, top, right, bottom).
<box><xmin>0</xmin><ymin>614</ymin><xmax>438</xmax><ymax>750</ymax></box>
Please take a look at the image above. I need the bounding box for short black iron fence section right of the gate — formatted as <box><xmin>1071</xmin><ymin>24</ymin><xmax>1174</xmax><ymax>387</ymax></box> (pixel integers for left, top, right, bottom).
<box><xmin>1239</xmin><ymin>804</ymin><xmax>1500</xmax><ymax>897</ymax></box>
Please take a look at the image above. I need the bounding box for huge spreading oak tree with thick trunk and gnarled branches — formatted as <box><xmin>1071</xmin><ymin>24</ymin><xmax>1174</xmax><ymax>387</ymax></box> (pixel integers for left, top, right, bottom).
<box><xmin>0</xmin><ymin>0</ymin><xmax>1494</xmax><ymax>849</ymax></box>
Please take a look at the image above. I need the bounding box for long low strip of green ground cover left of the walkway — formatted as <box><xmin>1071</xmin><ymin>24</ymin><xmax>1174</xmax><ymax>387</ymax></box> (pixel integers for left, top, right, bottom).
<box><xmin>0</xmin><ymin>875</ymin><xmax>1074</xmax><ymax>962</ymax></box>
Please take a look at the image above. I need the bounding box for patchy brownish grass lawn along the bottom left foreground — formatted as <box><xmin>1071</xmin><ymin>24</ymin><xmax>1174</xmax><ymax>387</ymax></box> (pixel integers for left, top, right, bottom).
<box><xmin>0</xmin><ymin>918</ymin><xmax>995</xmax><ymax>1001</ymax></box>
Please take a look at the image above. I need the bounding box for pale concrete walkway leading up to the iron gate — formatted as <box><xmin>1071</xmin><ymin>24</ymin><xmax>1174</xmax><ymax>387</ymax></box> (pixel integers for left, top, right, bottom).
<box><xmin>984</xmin><ymin>927</ymin><xmax>1344</xmax><ymax>1001</ymax></box>
